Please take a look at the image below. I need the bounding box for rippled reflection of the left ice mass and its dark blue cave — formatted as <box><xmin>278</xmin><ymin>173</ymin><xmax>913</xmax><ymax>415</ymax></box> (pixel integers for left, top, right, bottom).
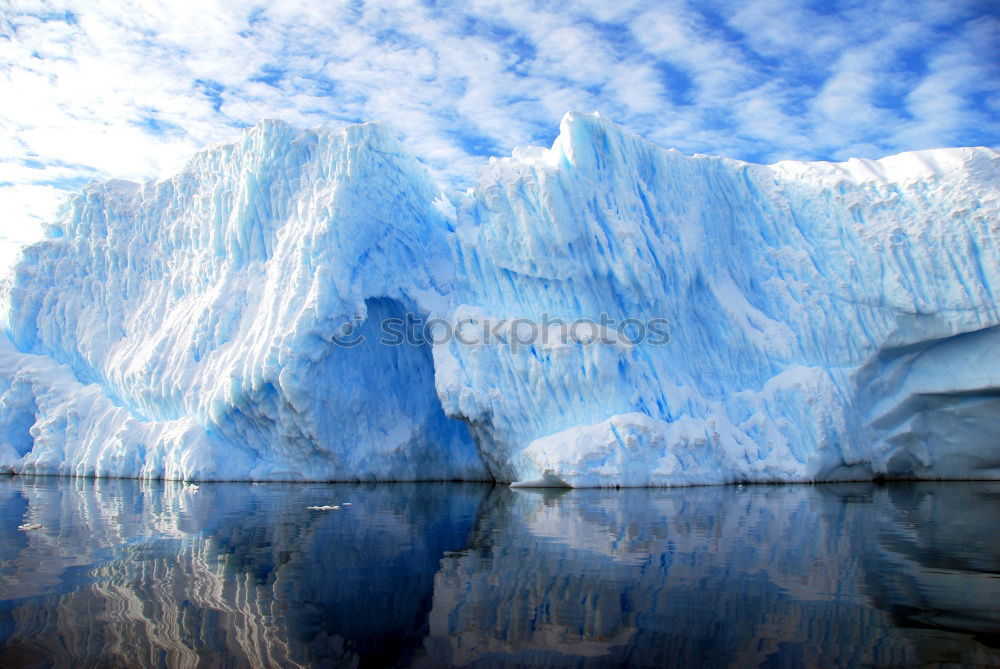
<box><xmin>0</xmin><ymin>480</ymin><xmax>483</xmax><ymax>667</ymax></box>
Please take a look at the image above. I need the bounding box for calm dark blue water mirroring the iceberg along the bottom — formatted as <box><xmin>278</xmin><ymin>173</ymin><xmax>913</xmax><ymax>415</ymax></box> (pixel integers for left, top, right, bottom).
<box><xmin>0</xmin><ymin>478</ymin><xmax>1000</xmax><ymax>667</ymax></box>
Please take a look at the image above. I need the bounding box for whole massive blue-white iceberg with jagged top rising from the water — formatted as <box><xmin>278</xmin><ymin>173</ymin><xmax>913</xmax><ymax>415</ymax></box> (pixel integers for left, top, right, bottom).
<box><xmin>0</xmin><ymin>113</ymin><xmax>1000</xmax><ymax>487</ymax></box>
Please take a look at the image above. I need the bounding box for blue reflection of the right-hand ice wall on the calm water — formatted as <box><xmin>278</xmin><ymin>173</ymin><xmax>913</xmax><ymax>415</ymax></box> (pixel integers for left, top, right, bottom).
<box><xmin>425</xmin><ymin>484</ymin><xmax>1000</xmax><ymax>666</ymax></box>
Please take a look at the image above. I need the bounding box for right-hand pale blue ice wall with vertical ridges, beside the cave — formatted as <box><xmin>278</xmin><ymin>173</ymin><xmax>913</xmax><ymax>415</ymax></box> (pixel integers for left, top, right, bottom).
<box><xmin>438</xmin><ymin>114</ymin><xmax>1000</xmax><ymax>486</ymax></box>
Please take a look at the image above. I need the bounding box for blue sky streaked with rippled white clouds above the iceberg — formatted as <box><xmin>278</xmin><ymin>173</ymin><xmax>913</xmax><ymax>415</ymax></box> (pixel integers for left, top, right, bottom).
<box><xmin>0</xmin><ymin>0</ymin><xmax>1000</xmax><ymax>265</ymax></box>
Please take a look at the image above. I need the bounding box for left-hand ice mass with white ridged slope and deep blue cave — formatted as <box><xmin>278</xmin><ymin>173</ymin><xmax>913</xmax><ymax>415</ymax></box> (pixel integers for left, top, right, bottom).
<box><xmin>0</xmin><ymin>121</ymin><xmax>489</xmax><ymax>480</ymax></box>
